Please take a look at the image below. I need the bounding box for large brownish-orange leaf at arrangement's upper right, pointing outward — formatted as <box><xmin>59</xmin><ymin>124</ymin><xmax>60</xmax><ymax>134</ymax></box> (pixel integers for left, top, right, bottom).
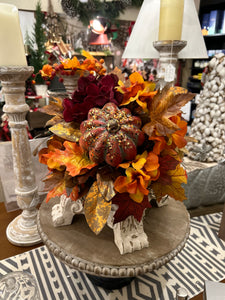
<box><xmin>142</xmin><ymin>87</ymin><xmax>194</xmax><ymax>137</ymax></box>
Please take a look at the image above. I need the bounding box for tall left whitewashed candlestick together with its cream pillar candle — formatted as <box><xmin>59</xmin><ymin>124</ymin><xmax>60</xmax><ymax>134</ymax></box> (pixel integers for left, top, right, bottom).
<box><xmin>0</xmin><ymin>3</ymin><xmax>41</xmax><ymax>246</ymax></box>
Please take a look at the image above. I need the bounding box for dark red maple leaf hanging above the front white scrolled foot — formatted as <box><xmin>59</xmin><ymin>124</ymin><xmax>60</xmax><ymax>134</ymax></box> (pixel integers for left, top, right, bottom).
<box><xmin>112</xmin><ymin>193</ymin><xmax>151</xmax><ymax>224</ymax></box>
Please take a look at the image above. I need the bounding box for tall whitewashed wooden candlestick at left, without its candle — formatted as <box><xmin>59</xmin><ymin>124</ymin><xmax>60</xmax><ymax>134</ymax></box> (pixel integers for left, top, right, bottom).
<box><xmin>0</xmin><ymin>66</ymin><xmax>41</xmax><ymax>246</ymax></box>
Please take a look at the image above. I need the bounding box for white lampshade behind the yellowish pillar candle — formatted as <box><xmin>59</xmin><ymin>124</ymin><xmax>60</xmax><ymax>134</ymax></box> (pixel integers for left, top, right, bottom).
<box><xmin>122</xmin><ymin>0</ymin><xmax>208</xmax><ymax>59</ymax></box>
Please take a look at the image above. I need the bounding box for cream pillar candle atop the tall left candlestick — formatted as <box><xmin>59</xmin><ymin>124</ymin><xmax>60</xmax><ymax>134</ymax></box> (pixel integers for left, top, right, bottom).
<box><xmin>0</xmin><ymin>3</ymin><xmax>27</xmax><ymax>66</ymax></box>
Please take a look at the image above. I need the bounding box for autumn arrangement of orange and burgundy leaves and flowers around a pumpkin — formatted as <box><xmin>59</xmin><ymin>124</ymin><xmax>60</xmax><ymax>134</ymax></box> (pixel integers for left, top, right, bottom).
<box><xmin>39</xmin><ymin>54</ymin><xmax>194</xmax><ymax>234</ymax></box>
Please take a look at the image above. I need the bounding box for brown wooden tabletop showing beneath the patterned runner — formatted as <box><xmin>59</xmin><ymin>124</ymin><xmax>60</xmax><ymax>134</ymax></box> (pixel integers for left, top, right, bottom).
<box><xmin>0</xmin><ymin>202</ymin><xmax>225</xmax><ymax>300</ymax></box>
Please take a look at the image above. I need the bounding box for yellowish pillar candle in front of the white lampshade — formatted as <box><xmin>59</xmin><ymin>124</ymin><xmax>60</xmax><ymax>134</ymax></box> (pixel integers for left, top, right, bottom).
<box><xmin>158</xmin><ymin>0</ymin><xmax>184</xmax><ymax>41</ymax></box>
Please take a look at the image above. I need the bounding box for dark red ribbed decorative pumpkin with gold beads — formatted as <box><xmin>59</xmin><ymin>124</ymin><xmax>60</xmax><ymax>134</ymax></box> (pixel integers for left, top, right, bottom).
<box><xmin>79</xmin><ymin>103</ymin><xmax>145</xmax><ymax>167</ymax></box>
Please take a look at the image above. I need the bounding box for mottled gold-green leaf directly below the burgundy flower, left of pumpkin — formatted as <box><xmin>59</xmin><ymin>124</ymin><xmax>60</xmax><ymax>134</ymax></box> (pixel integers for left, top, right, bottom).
<box><xmin>49</xmin><ymin>122</ymin><xmax>81</xmax><ymax>142</ymax></box>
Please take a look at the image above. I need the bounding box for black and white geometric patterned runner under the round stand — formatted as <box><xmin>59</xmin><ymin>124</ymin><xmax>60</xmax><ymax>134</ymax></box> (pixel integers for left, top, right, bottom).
<box><xmin>0</xmin><ymin>213</ymin><xmax>225</xmax><ymax>300</ymax></box>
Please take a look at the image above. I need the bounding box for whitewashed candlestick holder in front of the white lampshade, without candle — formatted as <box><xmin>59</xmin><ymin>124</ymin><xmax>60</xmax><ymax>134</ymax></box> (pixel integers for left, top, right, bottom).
<box><xmin>153</xmin><ymin>40</ymin><xmax>187</xmax><ymax>89</ymax></box>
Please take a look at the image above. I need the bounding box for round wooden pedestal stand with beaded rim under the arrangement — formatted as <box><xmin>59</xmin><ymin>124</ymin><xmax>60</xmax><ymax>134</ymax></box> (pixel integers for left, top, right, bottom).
<box><xmin>37</xmin><ymin>199</ymin><xmax>190</xmax><ymax>289</ymax></box>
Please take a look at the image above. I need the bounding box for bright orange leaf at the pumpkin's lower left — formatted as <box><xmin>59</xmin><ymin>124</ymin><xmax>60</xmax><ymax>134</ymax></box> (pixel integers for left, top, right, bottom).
<box><xmin>52</xmin><ymin>141</ymin><xmax>96</xmax><ymax>176</ymax></box>
